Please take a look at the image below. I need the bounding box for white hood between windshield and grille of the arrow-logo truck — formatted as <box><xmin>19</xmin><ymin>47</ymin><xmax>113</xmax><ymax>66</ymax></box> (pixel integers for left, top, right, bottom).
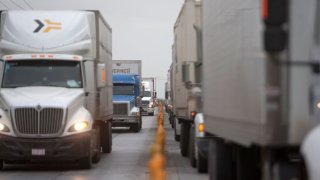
<box><xmin>0</xmin><ymin>87</ymin><xmax>84</xmax><ymax>108</ymax></box>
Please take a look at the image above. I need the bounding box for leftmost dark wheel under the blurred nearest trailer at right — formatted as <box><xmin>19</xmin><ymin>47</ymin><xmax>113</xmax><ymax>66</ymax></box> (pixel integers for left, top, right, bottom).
<box><xmin>208</xmin><ymin>138</ymin><xmax>234</xmax><ymax>180</ymax></box>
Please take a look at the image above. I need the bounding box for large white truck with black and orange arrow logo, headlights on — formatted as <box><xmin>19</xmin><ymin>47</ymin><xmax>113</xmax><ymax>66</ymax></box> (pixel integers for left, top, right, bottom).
<box><xmin>0</xmin><ymin>11</ymin><xmax>113</xmax><ymax>169</ymax></box>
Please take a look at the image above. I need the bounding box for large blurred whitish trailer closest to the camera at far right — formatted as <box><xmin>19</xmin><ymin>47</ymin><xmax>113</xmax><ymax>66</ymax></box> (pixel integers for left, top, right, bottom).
<box><xmin>203</xmin><ymin>0</ymin><xmax>320</xmax><ymax>180</ymax></box>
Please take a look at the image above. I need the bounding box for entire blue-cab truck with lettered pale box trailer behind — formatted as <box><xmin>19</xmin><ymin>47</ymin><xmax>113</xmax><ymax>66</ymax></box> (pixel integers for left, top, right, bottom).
<box><xmin>112</xmin><ymin>60</ymin><xmax>143</xmax><ymax>132</ymax></box>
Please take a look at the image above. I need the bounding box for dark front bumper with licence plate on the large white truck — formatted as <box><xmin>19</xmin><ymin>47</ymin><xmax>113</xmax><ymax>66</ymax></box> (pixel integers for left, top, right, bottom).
<box><xmin>0</xmin><ymin>131</ymin><xmax>93</xmax><ymax>161</ymax></box>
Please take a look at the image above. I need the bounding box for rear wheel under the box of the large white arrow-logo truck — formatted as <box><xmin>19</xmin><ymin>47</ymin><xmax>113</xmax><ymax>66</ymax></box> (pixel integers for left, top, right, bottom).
<box><xmin>100</xmin><ymin>120</ymin><xmax>112</xmax><ymax>153</ymax></box>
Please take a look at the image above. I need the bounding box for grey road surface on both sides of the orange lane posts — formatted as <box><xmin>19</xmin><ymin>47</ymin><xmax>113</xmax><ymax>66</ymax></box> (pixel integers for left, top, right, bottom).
<box><xmin>0</xmin><ymin>111</ymin><xmax>208</xmax><ymax>180</ymax></box>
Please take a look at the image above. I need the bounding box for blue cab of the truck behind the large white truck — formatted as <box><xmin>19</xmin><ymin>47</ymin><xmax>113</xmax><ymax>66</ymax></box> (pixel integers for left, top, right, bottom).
<box><xmin>112</xmin><ymin>74</ymin><xmax>142</xmax><ymax>132</ymax></box>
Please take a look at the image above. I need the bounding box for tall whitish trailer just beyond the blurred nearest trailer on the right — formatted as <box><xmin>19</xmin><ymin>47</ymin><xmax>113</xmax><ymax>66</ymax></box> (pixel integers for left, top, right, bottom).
<box><xmin>172</xmin><ymin>0</ymin><xmax>201</xmax><ymax>156</ymax></box>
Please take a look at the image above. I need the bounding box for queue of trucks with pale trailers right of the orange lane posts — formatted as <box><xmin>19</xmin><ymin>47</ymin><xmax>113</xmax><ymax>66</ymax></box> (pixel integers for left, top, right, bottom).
<box><xmin>166</xmin><ymin>0</ymin><xmax>320</xmax><ymax>180</ymax></box>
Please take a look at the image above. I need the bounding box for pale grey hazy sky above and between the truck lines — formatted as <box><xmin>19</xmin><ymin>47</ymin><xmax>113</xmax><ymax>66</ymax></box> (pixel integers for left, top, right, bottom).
<box><xmin>0</xmin><ymin>0</ymin><xmax>184</xmax><ymax>97</ymax></box>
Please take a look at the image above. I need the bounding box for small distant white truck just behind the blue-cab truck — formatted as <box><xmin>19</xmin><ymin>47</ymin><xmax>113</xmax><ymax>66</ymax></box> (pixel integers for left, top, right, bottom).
<box><xmin>142</xmin><ymin>78</ymin><xmax>157</xmax><ymax>116</ymax></box>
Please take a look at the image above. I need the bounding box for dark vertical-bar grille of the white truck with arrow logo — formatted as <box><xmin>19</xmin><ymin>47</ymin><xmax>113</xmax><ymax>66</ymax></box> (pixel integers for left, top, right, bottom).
<box><xmin>14</xmin><ymin>108</ymin><xmax>63</xmax><ymax>135</ymax></box>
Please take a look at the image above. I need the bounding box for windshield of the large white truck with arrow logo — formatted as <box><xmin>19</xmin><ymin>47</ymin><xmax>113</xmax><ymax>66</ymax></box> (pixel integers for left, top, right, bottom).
<box><xmin>2</xmin><ymin>60</ymin><xmax>83</xmax><ymax>88</ymax></box>
